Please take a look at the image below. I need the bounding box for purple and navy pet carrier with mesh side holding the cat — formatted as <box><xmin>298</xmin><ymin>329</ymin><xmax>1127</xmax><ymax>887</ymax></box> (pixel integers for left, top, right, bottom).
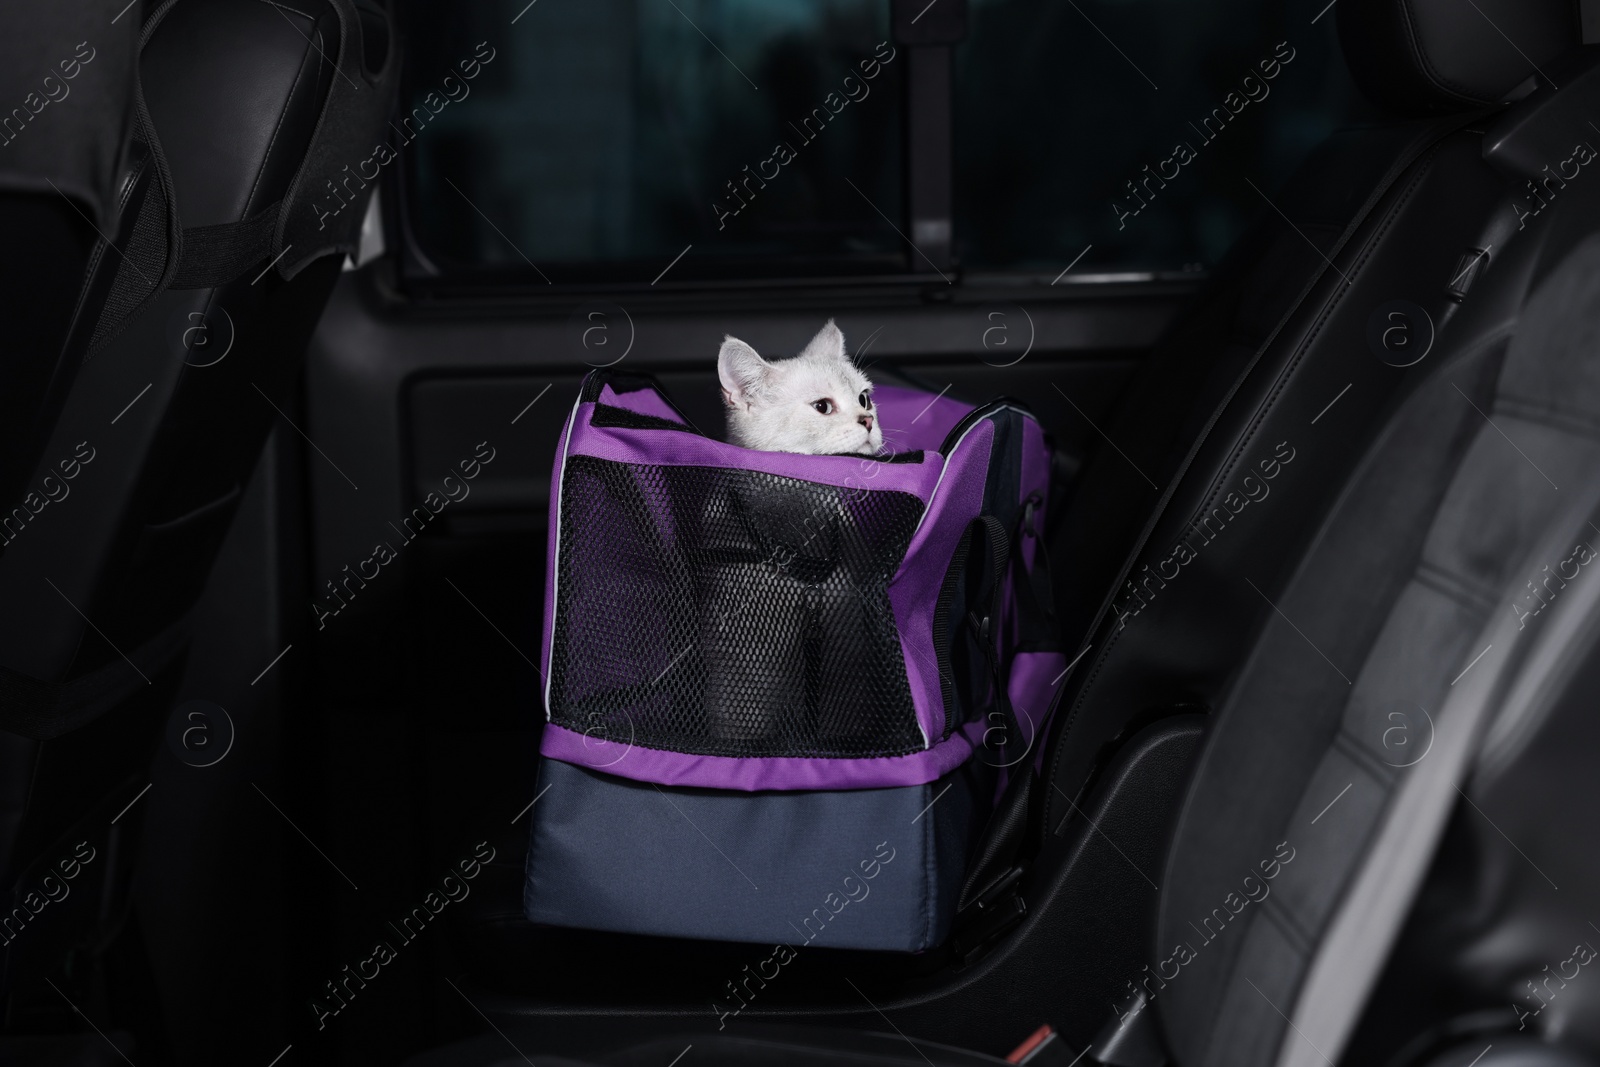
<box><xmin>525</xmin><ymin>371</ymin><xmax>1066</xmax><ymax>952</ymax></box>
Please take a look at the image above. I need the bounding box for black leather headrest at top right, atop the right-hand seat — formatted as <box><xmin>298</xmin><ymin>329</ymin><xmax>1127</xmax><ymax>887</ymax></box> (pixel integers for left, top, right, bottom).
<box><xmin>1338</xmin><ymin>0</ymin><xmax>1582</xmax><ymax>115</ymax></box>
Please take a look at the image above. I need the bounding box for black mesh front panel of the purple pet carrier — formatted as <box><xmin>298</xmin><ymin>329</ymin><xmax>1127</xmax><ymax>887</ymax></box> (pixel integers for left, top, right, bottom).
<box><xmin>550</xmin><ymin>456</ymin><xmax>923</xmax><ymax>757</ymax></box>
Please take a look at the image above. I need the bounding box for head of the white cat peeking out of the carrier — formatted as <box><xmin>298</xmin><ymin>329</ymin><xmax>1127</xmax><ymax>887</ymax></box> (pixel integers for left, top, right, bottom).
<box><xmin>717</xmin><ymin>318</ymin><xmax>883</xmax><ymax>456</ymax></box>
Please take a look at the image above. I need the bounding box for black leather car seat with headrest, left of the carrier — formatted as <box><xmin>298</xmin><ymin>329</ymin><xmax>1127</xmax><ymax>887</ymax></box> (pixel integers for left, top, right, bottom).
<box><xmin>0</xmin><ymin>0</ymin><xmax>398</xmax><ymax>1036</ymax></box>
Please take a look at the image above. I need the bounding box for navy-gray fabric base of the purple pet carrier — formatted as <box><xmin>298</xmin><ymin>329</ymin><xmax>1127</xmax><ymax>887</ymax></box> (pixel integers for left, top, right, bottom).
<box><xmin>523</xmin><ymin>760</ymin><xmax>994</xmax><ymax>952</ymax></box>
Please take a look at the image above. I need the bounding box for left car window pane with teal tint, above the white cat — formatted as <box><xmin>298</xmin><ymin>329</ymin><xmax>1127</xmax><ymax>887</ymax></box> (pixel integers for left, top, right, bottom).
<box><xmin>395</xmin><ymin>0</ymin><xmax>904</xmax><ymax>282</ymax></box>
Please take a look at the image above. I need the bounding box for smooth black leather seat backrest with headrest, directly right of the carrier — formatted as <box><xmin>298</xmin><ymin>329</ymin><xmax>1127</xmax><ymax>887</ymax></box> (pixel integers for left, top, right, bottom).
<box><xmin>1045</xmin><ymin>0</ymin><xmax>1581</xmax><ymax>827</ymax></box>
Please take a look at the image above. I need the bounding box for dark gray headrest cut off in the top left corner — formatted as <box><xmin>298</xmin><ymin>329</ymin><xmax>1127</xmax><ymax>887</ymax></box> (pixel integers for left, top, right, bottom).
<box><xmin>0</xmin><ymin>0</ymin><xmax>139</xmax><ymax>230</ymax></box>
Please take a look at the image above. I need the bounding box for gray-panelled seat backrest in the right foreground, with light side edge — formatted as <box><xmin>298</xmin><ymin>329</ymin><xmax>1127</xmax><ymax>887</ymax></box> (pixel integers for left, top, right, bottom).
<box><xmin>1155</xmin><ymin>87</ymin><xmax>1600</xmax><ymax>1064</ymax></box>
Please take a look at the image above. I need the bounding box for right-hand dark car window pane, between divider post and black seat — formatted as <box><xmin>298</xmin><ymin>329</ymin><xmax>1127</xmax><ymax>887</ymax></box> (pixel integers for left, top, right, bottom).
<box><xmin>955</xmin><ymin>0</ymin><xmax>1371</xmax><ymax>274</ymax></box>
